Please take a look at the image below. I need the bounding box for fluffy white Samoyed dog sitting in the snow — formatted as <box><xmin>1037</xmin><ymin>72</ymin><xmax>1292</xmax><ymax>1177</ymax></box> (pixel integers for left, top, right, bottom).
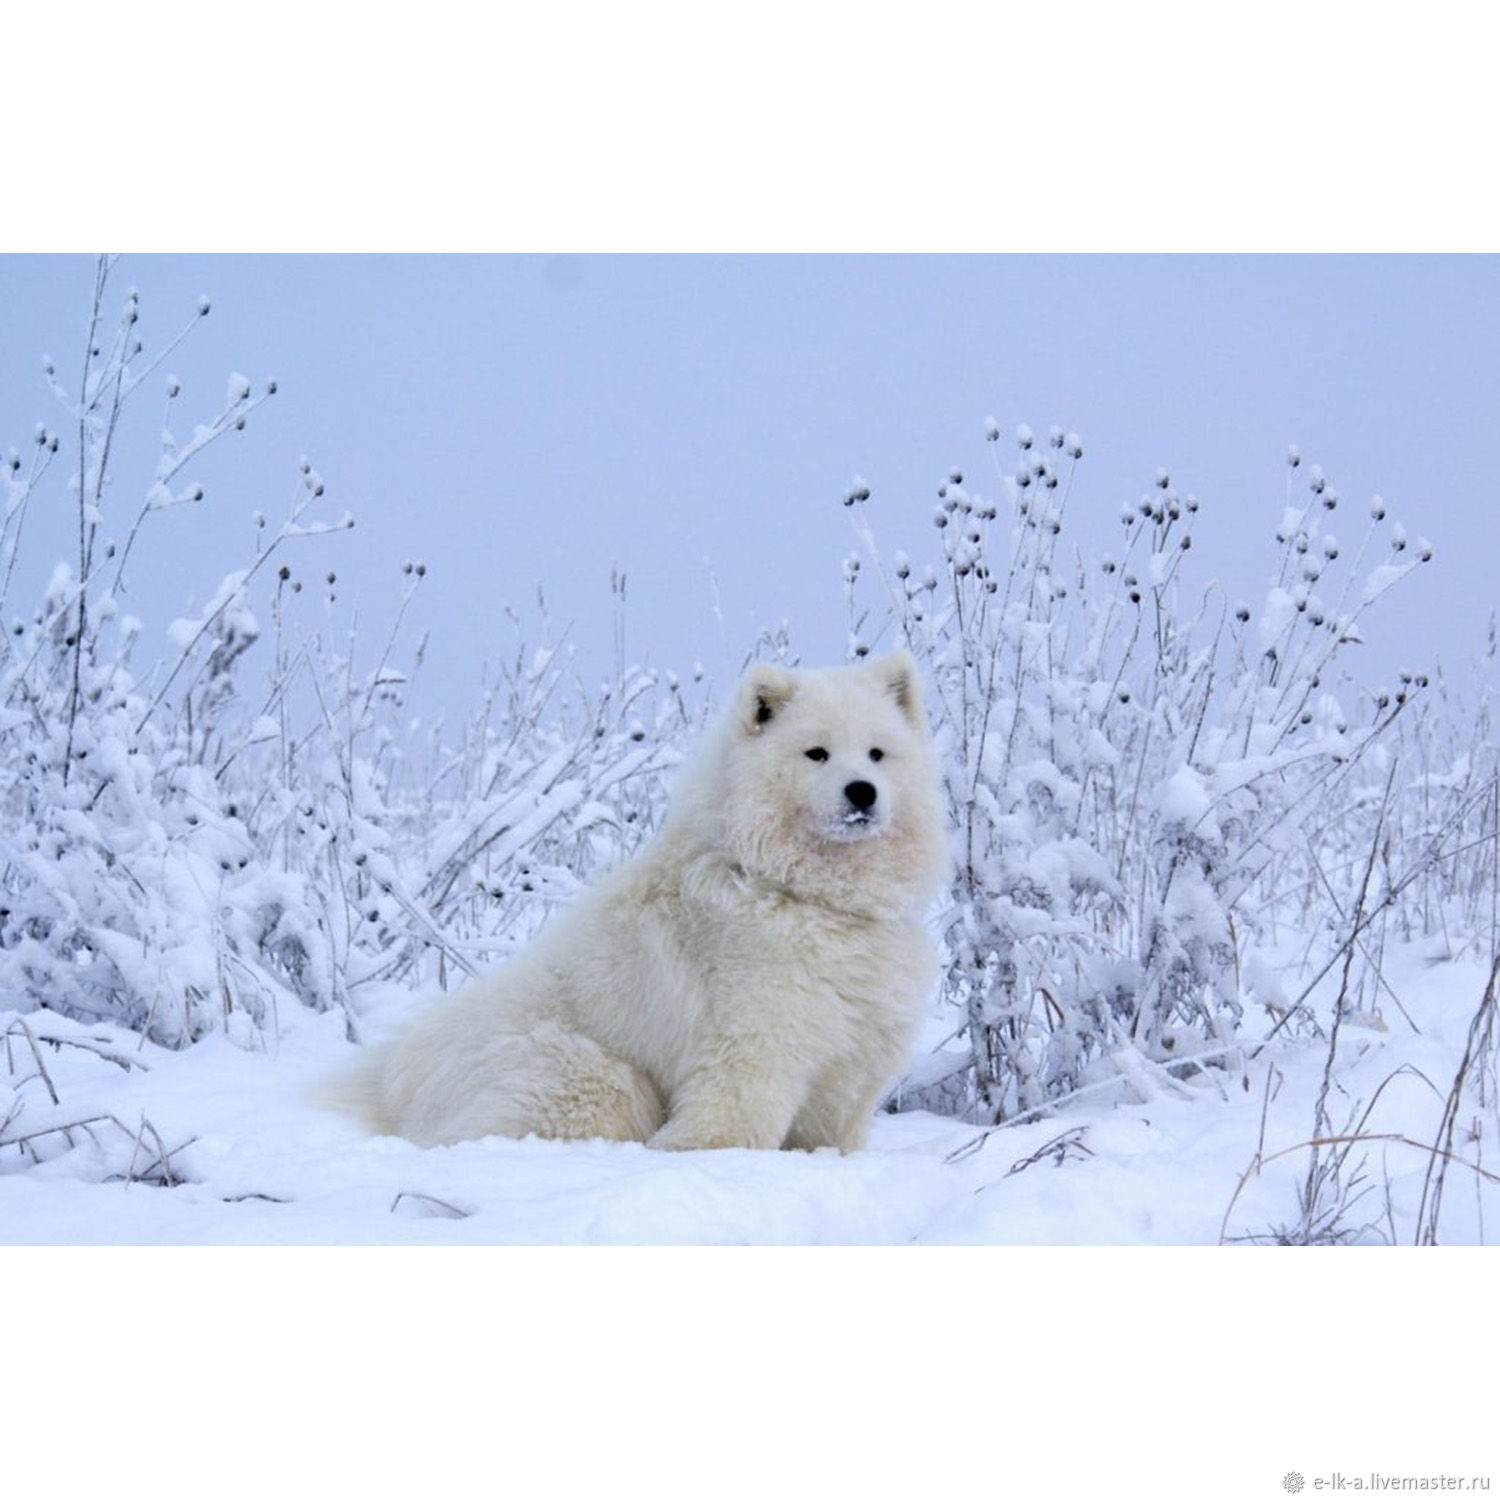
<box><xmin>339</xmin><ymin>651</ymin><xmax>947</xmax><ymax>1151</ymax></box>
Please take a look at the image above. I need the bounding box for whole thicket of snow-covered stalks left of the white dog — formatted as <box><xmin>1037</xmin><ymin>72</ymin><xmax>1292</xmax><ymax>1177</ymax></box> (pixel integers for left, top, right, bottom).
<box><xmin>0</xmin><ymin>260</ymin><xmax>698</xmax><ymax>1046</ymax></box>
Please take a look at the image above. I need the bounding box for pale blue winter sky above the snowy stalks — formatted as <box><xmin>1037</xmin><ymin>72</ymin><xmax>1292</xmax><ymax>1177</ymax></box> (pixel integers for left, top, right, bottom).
<box><xmin>0</xmin><ymin>257</ymin><xmax>1500</xmax><ymax>711</ymax></box>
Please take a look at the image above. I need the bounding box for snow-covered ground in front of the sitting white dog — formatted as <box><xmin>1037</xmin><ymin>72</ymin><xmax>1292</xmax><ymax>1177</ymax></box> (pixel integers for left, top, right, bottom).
<box><xmin>0</xmin><ymin>950</ymin><xmax>1500</xmax><ymax>1245</ymax></box>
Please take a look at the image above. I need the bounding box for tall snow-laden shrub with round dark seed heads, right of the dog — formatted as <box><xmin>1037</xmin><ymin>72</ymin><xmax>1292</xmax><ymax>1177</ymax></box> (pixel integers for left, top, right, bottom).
<box><xmin>845</xmin><ymin>423</ymin><xmax>1452</xmax><ymax>1121</ymax></box>
